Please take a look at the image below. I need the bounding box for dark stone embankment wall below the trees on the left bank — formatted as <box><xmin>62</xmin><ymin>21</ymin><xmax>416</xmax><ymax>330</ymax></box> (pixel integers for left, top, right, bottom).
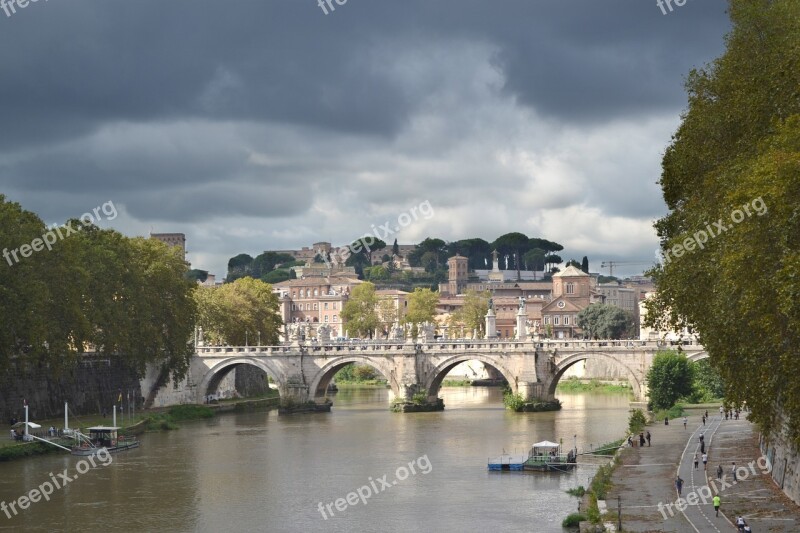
<box><xmin>0</xmin><ymin>357</ymin><xmax>142</xmax><ymax>424</ymax></box>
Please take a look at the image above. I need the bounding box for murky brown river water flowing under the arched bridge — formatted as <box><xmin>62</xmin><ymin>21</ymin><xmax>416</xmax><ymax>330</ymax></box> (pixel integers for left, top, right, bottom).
<box><xmin>0</xmin><ymin>387</ymin><xmax>628</xmax><ymax>533</ymax></box>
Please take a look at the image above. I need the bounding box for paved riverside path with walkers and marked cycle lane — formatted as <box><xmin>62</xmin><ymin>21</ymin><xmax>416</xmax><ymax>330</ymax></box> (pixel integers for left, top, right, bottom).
<box><xmin>607</xmin><ymin>409</ymin><xmax>800</xmax><ymax>533</ymax></box>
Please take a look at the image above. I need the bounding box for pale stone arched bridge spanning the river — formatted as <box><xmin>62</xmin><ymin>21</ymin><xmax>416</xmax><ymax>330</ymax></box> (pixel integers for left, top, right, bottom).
<box><xmin>187</xmin><ymin>340</ymin><xmax>708</xmax><ymax>403</ymax></box>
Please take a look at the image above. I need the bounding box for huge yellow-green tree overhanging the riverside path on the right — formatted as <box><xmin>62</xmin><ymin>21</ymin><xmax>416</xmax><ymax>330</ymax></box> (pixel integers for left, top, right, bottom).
<box><xmin>648</xmin><ymin>0</ymin><xmax>800</xmax><ymax>444</ymax></box>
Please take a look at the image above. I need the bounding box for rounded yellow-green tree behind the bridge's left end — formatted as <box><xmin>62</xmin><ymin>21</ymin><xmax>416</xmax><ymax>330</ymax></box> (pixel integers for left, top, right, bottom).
<box><xmin>195</xmin><ymin>277</ymin><xmax>283</xmax><ymax>346</ymax></box>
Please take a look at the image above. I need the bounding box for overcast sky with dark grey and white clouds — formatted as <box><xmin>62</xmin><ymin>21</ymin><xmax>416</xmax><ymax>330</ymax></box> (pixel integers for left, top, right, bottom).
<box><xmin>0</xmin><ymin>0</ymin><xmax>729</xmax><ymax>275</ymax></box>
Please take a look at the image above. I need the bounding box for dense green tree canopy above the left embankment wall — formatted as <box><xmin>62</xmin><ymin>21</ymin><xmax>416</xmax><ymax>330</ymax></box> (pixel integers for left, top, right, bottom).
<box><xmin>0</xmin><ymin>195</ymin><xmax>196</xmax><ymax>379</ymax></box>
